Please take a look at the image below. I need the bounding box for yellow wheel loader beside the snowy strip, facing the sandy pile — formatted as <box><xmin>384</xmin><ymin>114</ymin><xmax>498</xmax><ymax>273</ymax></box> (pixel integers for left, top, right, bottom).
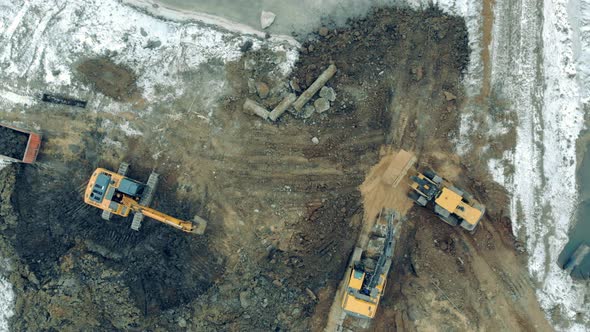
<box><xmin>408</xmin><ymin>170</ymin><xmax>485</xmax><ymax>232</ymax></box>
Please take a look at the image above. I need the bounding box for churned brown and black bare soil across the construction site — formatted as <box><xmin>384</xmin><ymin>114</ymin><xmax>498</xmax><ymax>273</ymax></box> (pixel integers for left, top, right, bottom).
<box><xmin>0</xmin><ymin>8</ymin><xmax>551</xmax><ymax>331</ymax></box>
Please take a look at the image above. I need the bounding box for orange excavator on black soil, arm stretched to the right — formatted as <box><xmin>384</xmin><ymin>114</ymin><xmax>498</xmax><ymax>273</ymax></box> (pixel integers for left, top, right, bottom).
<box><xmin>84</xmin><ymin>163</ymin><xmax>207</xmax><ymax>234</ymax></box>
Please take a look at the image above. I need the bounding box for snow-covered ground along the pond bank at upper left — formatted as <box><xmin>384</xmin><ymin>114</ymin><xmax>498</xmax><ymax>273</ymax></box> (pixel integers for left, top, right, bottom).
<box><xmin>0</xmin><ymin>0</ymin><xmax>297</xmax><ymax>102</ymax></box>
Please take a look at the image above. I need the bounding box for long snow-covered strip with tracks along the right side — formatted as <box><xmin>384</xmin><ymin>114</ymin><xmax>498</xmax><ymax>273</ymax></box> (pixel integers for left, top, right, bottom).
<box><xmin>437</xmin><ymin>0</ymin><xmax>590</xmax><ymax>331</ymax></box>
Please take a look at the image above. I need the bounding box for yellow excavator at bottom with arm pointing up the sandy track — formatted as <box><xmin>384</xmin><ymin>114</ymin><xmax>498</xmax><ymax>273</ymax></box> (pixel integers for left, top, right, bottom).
<box><xmin>342</xmin><ymin>210</ymin><xmax>399</xmax><ymax>319</ymax></box>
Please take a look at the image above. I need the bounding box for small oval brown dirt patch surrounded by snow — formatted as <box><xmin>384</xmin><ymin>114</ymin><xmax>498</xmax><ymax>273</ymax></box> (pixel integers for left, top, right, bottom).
<box><xmin>77</xmin><ymin>58</ymin><xmax>140</xmax><ymax>101</ymax></box>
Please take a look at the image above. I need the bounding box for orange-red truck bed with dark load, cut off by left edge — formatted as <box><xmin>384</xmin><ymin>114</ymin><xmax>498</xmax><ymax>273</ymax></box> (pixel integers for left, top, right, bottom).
<box><xmin>0</xmin><ymin>124</ymin><xmax>41</xmax><ymax>164</ymax></box>
